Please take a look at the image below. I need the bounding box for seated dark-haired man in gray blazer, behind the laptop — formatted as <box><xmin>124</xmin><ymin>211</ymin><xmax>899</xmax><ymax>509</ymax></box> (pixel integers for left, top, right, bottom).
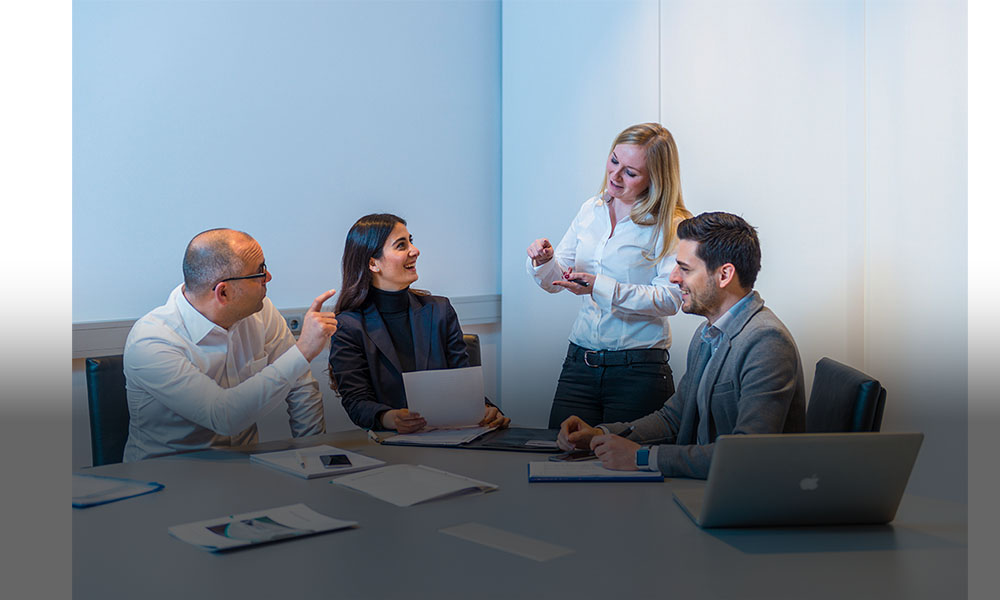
<box><xmin>559</xmin><ymin>212</ymin><xmax>805</xmax><ymax>479</ymax></box>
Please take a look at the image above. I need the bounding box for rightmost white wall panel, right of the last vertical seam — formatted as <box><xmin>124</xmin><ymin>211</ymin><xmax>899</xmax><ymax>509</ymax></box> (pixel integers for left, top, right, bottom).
<box><xmin>865</xmin><ymin>0</ymin><xmax>968</xmax><ymax>500</ymax></box>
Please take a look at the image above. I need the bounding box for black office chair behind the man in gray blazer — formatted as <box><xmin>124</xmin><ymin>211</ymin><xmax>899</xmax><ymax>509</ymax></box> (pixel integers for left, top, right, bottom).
<box><xmin>806</xmin><ymin>357</ymin><xmax>885</xmax><ymax>433</ymax></box>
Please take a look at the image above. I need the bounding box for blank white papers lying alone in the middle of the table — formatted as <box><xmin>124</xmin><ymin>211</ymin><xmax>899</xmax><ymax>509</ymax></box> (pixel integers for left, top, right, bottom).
<box><xmin>330</xmin><ymin>465</ymin><xmax>497</xmax><ymax>506</ymax></box>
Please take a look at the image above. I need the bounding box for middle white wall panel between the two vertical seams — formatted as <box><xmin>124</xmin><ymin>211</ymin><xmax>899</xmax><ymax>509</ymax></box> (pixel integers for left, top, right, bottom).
<box><xmin>661</xmin><ymin>0</ymin><xmax>865</xmax><ymax>382</ymax></box>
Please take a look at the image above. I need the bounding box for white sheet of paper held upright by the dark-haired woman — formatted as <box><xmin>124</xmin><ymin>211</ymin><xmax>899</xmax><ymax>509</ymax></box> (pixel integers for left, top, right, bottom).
<box><xmin>403</xmin><ymin>367</ymin><xmax>486</xmax><ymax>427</ymax></box>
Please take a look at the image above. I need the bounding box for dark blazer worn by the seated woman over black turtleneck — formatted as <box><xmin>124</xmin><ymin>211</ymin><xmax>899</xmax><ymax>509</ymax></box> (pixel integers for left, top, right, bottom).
<box><xmin>330</xmin><ymin>292</ymin><xmax>469</xmax><ymax>429</ymax></box>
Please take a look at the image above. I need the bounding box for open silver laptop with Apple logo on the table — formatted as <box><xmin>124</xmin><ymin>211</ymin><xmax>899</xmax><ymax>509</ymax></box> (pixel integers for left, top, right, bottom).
<box><xmin>674</xmin><ymin>433</ymin><xmax>924</xmax><ymax>528</ymax></box>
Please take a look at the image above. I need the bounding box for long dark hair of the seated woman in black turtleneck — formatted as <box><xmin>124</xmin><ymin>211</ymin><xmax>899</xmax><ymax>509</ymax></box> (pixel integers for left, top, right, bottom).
<box><xmin>334</xmin><ymin>213</ymin><xmax>406</xmax><ymax>313</ymax></box>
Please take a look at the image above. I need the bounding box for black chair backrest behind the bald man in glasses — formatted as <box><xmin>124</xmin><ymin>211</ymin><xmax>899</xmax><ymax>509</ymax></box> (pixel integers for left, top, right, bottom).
<box><xmin>87</xmin><ymin>354</ymin><xmax>129</xmax><ymax>467</ymax></box>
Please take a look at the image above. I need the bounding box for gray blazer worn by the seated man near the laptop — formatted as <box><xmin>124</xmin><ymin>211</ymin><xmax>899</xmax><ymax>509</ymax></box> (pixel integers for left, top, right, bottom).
<box><xmin>605</xmin><ymin>292</ymin><xmax>806</xmax><ymax>479</ymax></box>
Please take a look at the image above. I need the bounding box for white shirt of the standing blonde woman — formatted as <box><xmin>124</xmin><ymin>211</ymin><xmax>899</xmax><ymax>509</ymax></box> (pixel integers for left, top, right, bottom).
<box><xmin>527</xmin><ymin>196</ymin><xmax>681</xmax><ymax>350</ymax></box>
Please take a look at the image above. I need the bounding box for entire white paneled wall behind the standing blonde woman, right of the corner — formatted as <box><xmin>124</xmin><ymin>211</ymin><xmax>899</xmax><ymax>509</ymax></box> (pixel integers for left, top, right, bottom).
<box><xmin>502</xmin><ymin>0</ymin><xmax>966</xmax><ymax>499</ymax></box>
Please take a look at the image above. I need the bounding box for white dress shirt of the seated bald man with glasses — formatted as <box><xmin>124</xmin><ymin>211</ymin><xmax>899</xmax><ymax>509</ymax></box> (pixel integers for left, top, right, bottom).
<box><xmin>124</xmin><ymin>285</ymin><xmax>326</xmax><ymax>462</ymax></box>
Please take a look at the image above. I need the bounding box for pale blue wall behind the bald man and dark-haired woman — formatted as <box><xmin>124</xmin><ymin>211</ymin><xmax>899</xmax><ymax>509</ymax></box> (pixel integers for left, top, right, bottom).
<box><xmin>73</xmin><ymin>0</ymin><xmax>500</xmax><ymax>322</ymax></box>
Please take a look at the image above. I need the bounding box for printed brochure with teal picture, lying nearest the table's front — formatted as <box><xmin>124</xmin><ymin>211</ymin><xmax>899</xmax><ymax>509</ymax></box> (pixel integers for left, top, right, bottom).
<box><xmin>167</xmin><ymin>504</ymin><xmax>357</xmax><ymax>552</ymax></box>
